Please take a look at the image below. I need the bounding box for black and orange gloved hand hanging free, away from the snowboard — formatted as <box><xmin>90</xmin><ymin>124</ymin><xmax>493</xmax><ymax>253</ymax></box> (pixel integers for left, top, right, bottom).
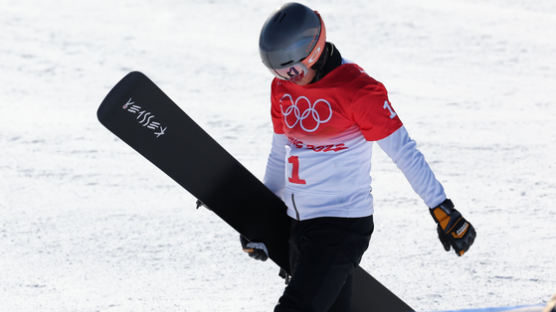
<box><xmin>430</xmin><ymin>199</ymin><xmax>477</xmax><ymax>256</ymax></box>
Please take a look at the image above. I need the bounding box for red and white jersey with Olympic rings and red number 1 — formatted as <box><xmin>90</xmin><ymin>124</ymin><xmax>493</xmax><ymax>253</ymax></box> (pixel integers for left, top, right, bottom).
<box><xmin>265</xmin><ymin>64</ymin><xmax>443</xmax><ymax>220</ymax></box>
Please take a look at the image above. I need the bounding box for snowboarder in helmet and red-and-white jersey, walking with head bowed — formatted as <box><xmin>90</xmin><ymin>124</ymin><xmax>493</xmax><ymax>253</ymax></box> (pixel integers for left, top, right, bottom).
<box><xmin>241</xmin><ymin>3</ymin><xmax>475</xmax><ymax>312</ymax></box>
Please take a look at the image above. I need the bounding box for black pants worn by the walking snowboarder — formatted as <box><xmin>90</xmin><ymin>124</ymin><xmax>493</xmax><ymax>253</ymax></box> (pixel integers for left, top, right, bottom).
<box><xmin>274</xmin><ymin>216</ymin><xmax>374</xmax><ymax>312</ymax></box>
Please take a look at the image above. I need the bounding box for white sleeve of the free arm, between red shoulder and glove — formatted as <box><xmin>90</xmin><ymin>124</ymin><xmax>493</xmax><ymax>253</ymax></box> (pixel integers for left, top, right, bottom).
<box><xmin>377</xmin><ymin>126</ymin><xmax>446</xmax><ymax>208</ymax></box>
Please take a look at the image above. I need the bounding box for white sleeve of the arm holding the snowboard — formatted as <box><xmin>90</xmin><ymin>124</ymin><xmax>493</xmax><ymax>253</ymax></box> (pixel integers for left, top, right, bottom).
<box><xmin>263</xmin><ymin>133</ymin><xmax>288</xmax><ymax>198</ymax></box>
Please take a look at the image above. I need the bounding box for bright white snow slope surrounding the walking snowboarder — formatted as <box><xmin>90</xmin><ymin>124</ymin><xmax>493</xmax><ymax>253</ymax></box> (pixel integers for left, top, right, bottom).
<box><xmin>0</xmin><ymin>0</ymin><xmax>556</xmax><ymax>311</ymax></box>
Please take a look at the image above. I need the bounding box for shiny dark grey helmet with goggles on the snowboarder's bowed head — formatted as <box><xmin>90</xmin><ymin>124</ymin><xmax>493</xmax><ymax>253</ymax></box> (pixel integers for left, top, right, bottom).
<box><xmin>259</xmin><ymin>3</ymin><xmax>326</xmax><ymax>78</ymax></box>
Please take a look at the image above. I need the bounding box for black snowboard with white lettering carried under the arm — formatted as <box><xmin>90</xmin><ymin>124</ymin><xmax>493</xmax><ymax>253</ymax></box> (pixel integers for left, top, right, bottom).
<box><xmin>97</xmin><ymin>72</ymin><xmax>414</xmax><ymax>312</ymax></box>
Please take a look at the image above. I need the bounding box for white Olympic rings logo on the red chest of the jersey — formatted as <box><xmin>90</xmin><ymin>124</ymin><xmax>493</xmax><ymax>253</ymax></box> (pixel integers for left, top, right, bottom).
<box><xmin>280</xmin><ymin>93</ymin><xmax>332</xmax><ymax>132</ymax></box>
